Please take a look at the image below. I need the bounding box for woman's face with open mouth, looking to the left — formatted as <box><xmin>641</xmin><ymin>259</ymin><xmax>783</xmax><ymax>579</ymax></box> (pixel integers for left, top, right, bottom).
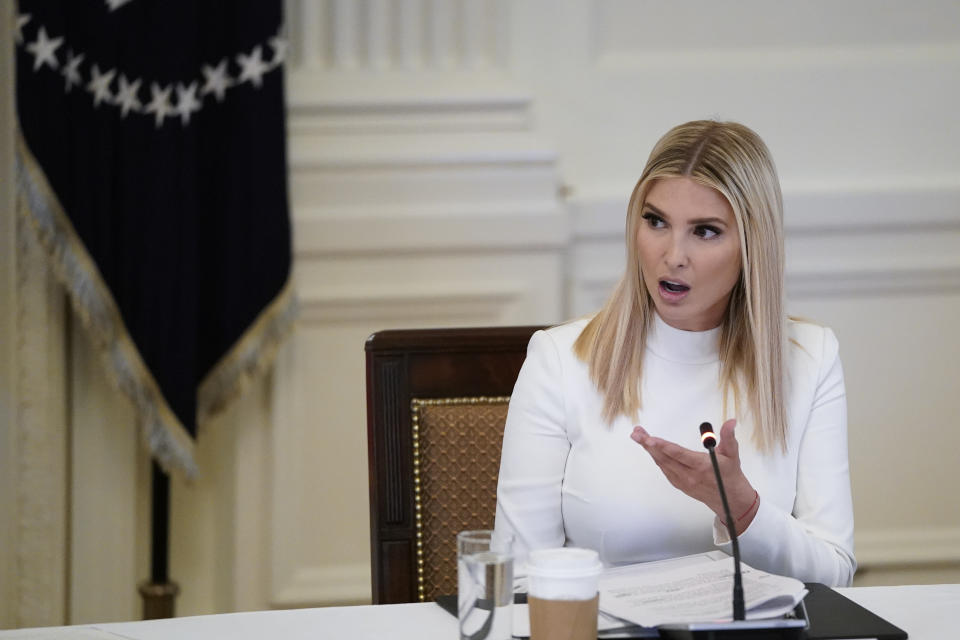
<box><xmin>637</xmin><ymin>178</ymin><xmax>740</xmax><ymax>331</ymax></box>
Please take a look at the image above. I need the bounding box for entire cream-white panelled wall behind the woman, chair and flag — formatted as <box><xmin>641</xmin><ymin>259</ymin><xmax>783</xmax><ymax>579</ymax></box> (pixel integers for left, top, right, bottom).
<box><xmin>1</xmin><ymin>0</ymin><xmax>960</xmax><ymax>621</ymax></box>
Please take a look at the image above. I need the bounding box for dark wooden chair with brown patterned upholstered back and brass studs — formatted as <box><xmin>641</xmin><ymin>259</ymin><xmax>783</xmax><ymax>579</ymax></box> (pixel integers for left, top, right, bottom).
<box><xmin>366</xmin><ymin>327</ymin><xmax>541</xmax><ymax>604</ymax></box>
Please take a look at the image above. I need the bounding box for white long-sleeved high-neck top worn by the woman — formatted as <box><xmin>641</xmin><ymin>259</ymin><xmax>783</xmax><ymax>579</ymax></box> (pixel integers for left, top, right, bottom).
<box><xmin>496</xmin><ymin>318</ymin><xmax>856</xmax><ymax>586</ymax></box>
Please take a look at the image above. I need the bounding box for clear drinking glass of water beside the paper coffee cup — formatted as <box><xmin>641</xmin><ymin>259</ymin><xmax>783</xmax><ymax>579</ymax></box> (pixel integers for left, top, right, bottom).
<box><xmin>457</xmin><ymin>530</ymin><xmax>513</xmax><ymax>640</ymax></box>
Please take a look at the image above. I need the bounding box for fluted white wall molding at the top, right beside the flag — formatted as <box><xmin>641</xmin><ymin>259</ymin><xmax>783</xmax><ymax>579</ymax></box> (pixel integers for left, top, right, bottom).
<box><xmin>287</xmin><ymin>0</ymin><xmax>531</xmax><ymax>139</ymax></box>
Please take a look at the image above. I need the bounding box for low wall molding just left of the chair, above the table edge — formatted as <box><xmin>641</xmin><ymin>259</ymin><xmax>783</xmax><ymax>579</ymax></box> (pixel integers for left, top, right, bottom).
<box><xmin>270</xmin><ymin>563</ymin><xmax>370</xmax><ymax>608</ymax></box>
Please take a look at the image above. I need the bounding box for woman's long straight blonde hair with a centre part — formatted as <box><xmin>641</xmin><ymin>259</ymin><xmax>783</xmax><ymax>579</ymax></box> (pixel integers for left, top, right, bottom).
<box><xmin>574</xmin><ymin>120</ymin><xmax>787</xmax><ymax>452</ymax></box>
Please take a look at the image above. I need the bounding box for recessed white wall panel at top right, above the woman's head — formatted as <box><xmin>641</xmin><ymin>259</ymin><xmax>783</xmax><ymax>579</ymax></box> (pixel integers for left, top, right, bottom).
<box><xmin>590</xmin><ymin>0</ymin><xmax>960</xmax><ymax>71</ymax></box>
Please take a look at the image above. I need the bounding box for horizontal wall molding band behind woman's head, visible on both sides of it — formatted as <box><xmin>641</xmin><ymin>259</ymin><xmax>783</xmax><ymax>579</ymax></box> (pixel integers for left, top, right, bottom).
<box><xmin>570</xmin><ymin>182</ymin><xmax>960</xmax><ymax>302</ymax></box>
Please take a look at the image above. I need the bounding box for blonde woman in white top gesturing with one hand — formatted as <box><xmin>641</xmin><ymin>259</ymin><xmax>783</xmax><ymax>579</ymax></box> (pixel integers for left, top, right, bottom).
<box><xmin>496</xmin><ymin>121</ymin><xmax>856</xmax><ymax>586</ymax></box>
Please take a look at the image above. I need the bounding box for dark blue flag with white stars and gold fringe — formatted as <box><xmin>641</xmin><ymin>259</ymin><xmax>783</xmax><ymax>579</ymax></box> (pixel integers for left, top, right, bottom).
<box><xmin>15</xmin><ymin>0</ymin><xmax>296</xmax><ymax>474</ymax></box>
